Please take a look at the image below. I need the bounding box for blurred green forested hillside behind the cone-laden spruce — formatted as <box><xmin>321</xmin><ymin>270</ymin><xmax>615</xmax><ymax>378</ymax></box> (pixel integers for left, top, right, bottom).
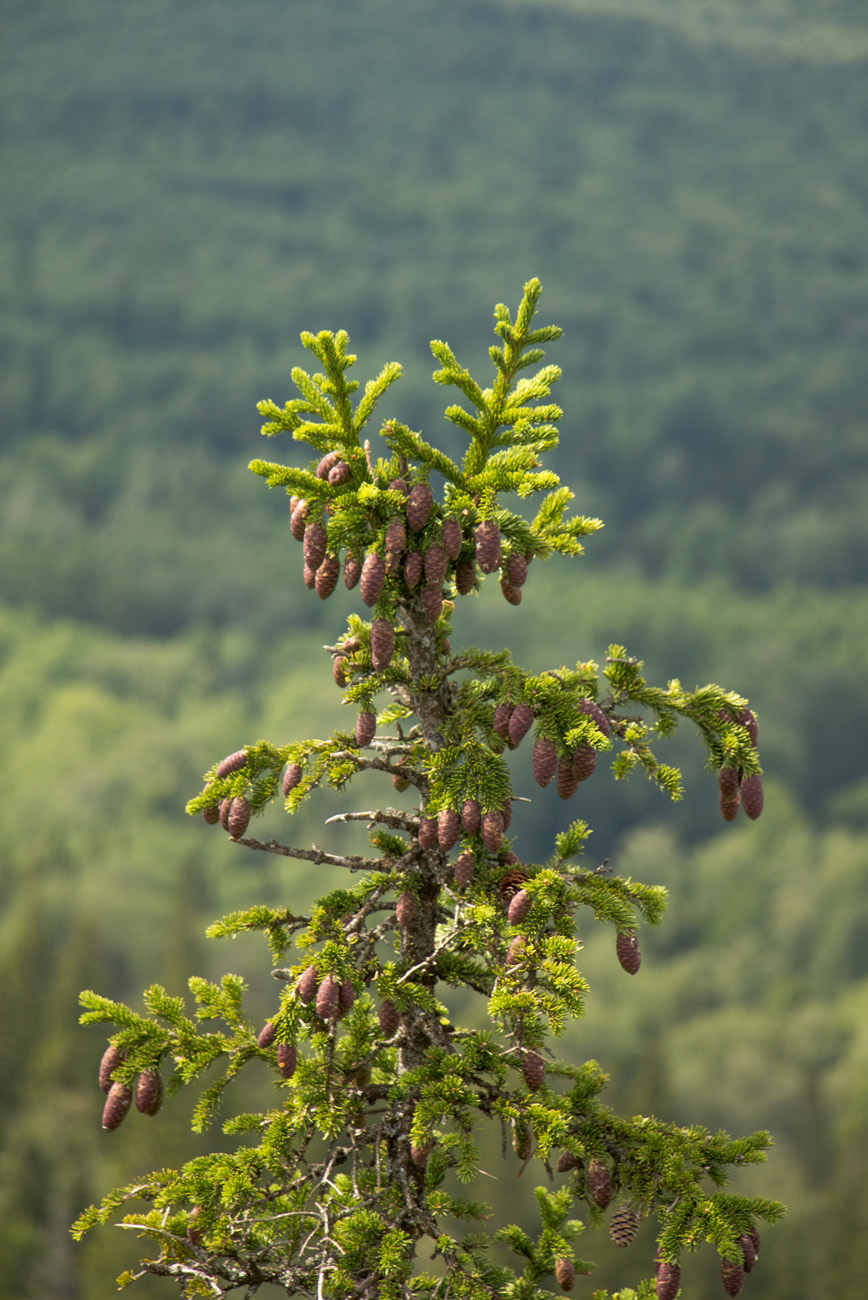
<box><xmin>0</xmin><ymin>0</ymin><xmax>868</xmax><ymax>1300</ymax></box>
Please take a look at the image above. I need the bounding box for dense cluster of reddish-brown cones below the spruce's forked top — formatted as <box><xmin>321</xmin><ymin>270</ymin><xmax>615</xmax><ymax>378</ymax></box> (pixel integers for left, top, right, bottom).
<box><xmin>290</xmin><ymin>451</ymin><xmax>530</xmax><ymax>621</ymax></box>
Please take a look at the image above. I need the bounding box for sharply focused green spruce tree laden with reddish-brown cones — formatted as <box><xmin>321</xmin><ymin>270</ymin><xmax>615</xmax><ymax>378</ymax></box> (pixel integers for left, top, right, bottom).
<box><xmin>74</xmin><ymin>281</ymin><xmax>782</xmax><ymax>1300</ymax></box>
